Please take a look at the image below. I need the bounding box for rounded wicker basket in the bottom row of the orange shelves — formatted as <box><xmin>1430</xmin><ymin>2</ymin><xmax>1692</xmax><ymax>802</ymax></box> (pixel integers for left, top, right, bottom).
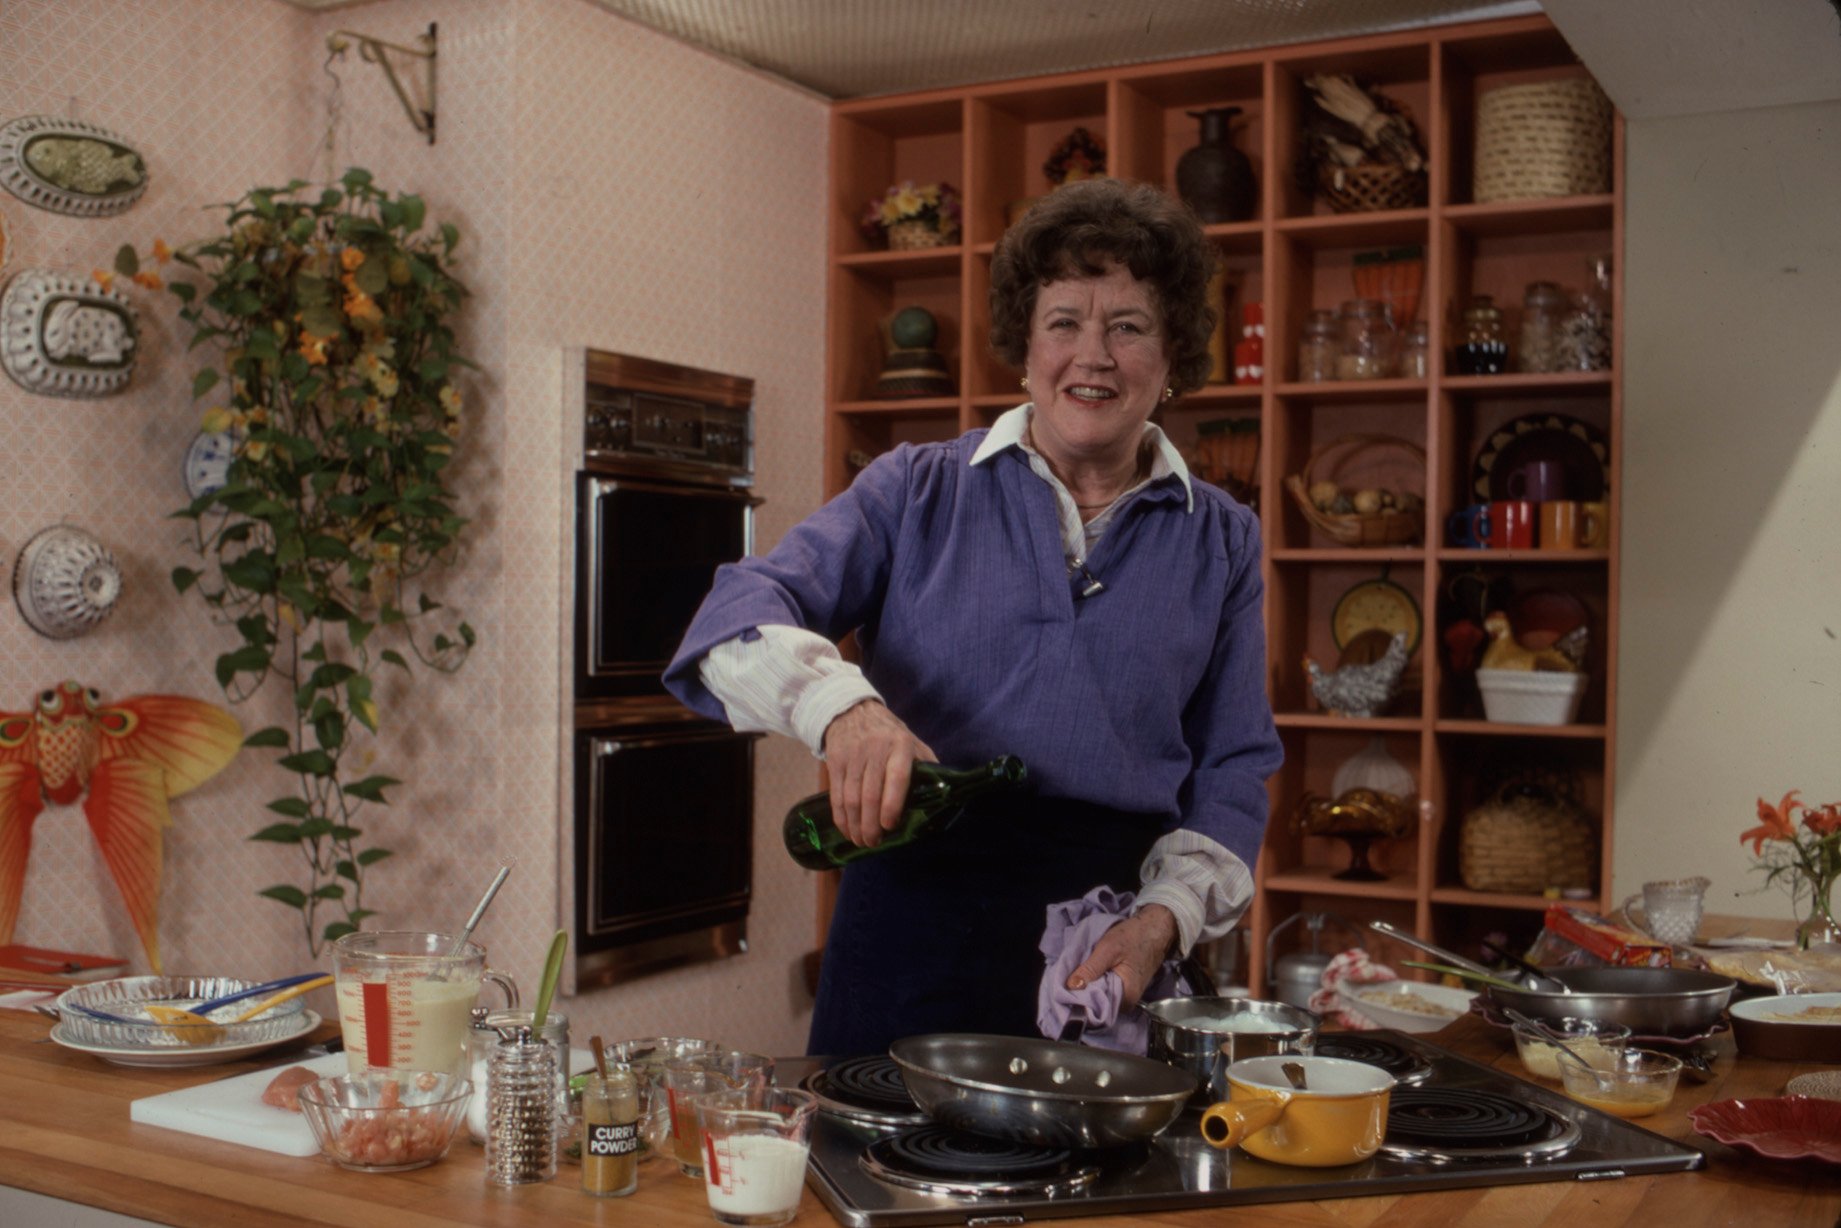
<box><xmin>1458</xmin><ymin>775</ymin><xmax>1598</xmax><ymax>895</ymax></box>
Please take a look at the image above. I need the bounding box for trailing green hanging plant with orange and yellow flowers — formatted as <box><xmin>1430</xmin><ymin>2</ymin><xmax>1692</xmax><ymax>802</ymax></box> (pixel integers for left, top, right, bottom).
<box><xmin>113</xmin><ymin>168</ymin><xmax>475</xmax><ymax>956</ymax></box>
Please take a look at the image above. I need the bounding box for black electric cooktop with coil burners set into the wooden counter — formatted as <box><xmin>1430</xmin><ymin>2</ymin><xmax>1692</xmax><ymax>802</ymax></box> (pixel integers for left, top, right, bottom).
<box><xmin>781</xmin><ymin>1031</ymin><xmax>1703</xmax><ymax>1228</ymax></box>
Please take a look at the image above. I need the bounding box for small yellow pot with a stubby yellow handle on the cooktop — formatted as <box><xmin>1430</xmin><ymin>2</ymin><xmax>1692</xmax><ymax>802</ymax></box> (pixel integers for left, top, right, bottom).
<box><xmin>1202</xmin><ymin>1055</ymin><xmax>1394</xmax><ymax>1167</ymax></box>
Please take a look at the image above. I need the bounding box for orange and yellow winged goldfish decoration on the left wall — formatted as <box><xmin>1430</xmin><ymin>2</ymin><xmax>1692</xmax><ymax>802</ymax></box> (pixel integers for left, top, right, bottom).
<box><xmin>0</xmin><ymin>681</ymin><xmax>243</xmax><ymax>972</ymax></box>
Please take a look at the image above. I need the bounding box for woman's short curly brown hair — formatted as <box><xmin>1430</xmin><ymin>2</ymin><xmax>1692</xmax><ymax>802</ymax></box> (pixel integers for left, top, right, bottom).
<box><xmin>990</xmin><ymin>179</ymin><xmax>1219</xmax><ymax>392</ymax></box>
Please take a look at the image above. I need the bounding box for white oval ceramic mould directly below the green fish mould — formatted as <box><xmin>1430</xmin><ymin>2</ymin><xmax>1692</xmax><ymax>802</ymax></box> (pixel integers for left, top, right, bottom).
<box><xmin>0</xmin><ymin>269</ymin><xmax>140</xmax><ymax>398</ymax></box>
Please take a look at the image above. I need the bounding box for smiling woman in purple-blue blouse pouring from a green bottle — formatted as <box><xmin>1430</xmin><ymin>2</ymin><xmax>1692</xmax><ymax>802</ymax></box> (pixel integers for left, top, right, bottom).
<box><xmin>666</xmin><ymin>179</ymin><xmax>1281</xmax><ymax>1055</ymax></box>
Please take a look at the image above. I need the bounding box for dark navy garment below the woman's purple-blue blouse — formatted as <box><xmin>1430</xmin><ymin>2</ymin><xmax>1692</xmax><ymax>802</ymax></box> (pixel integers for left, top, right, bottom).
<box><xmin>806</xmin><ymin>795</ymin><xmax>1165</xmax><ymax>1057</ymax></box>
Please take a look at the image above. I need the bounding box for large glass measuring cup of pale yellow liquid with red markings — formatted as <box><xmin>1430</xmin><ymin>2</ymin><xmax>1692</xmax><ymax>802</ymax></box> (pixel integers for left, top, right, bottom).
<box><xmin>333</xmin><ymin>930</ymin><xmax>517</xmax><ymax>1073</ymax></box>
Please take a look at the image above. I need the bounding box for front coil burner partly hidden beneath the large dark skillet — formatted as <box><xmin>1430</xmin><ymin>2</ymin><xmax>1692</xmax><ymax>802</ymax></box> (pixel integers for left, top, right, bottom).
<box><xmin>860</xmin><ymin>1125</ymin><xmax>1099</xmax><ymax>1199</ymax></box>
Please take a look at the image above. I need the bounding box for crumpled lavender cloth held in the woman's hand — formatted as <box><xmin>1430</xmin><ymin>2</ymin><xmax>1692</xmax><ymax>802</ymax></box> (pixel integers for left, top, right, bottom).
<box><xmin>1036</xmin><ymin>887</ymin><xmax>1189</xmax><ymax>1053</ymax></box>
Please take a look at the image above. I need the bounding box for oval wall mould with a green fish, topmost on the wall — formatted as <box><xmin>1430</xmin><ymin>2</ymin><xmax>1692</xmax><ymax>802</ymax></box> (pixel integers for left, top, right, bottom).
<box><xmin>0</xmin><ymin>116</ymin><xmax>147</xmax><ymax>217</ymax></box>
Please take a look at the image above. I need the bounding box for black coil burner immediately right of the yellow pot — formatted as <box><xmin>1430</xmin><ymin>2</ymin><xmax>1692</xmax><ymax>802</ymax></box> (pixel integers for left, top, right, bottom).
<box><xmin>1381</xmin><ymin>1088</ymin><xmax>1580</xmax><ymax>1164</ymax></box>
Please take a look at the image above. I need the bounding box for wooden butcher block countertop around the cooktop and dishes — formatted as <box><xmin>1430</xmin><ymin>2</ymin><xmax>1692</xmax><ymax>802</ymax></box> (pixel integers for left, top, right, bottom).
<box><xmin>0</xmin><ymin>1011</ymin><xmax>1841</xmax><ymax>1228</ymax></box>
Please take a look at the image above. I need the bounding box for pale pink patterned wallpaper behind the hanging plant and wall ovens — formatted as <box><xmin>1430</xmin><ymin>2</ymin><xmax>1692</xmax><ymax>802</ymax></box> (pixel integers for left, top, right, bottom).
<box><xmin>0</xmin><ymin>0</ymin><xmax>825</xmax><ymax>1053</ymax></box>
